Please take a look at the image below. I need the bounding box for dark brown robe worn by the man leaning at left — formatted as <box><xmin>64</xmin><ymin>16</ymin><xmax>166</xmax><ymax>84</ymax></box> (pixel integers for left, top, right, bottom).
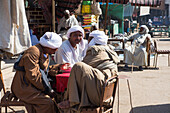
<box><xmin>11</xmin><ymin>44</ymin><xmax>56</xmax><ymax>113</ymax></box>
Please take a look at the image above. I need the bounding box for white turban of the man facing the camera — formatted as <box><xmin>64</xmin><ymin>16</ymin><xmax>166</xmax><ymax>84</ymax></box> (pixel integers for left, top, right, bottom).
<box><xmin>67</xmin><ymin>25</ymin><xmax>84</xmax><ymax>38</ymax></box>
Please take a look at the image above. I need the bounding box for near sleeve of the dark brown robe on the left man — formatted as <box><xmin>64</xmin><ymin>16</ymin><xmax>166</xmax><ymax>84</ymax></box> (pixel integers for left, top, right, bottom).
<box><xmin>24</xmin><ymin>52</ymin><xmax>44</xmax><ymax>91</ymax></box>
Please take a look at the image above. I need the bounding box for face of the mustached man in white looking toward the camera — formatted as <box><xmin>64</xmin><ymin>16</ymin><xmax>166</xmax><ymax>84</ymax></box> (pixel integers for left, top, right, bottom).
<box><xmin>69</xmin><ymin>31</ymin><xmax>83</xmax><ymax>45</ymax></box>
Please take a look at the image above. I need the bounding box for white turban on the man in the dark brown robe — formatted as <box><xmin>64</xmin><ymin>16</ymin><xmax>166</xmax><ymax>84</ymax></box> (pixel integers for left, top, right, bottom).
<box><xmin>40</xmin><ymin>32</ymin><xmax>62</xmax><ymax>49</ymax></box>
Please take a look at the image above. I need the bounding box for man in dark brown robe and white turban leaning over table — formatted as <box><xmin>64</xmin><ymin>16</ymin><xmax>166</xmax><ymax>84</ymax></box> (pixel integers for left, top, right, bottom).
<box><xmin>11</xmin><ymin>32</ymin><xmax>67</xmax><ymax>113</ymax></box>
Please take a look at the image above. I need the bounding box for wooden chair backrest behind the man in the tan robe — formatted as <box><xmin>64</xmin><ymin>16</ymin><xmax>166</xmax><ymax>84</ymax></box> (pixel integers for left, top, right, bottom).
<box><xmin>100</xmin><ymin>76</ymin><xmax>118</xmax><ymax>106</ymax></box>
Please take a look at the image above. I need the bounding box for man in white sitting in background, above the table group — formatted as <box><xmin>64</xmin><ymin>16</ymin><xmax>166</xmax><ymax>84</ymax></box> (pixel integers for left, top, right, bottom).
<box><xmin>57</xmin><ymin>10</ymin><xmax>78</xmax><ymax>40</ymax></box>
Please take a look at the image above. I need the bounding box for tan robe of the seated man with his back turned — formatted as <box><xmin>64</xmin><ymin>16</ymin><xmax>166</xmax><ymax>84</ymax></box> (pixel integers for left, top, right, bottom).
<box><xmin>64</xmin><ymin>46</ymin><xmax>119</xmax><ymax>113</ymax></box>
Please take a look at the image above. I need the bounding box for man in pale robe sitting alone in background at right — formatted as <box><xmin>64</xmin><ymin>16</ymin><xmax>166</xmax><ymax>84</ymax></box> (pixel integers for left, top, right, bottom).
<box><xmin>125</xmin><ymin>25</ymin><xmax>153</xmax><ymax>71</ymax></box>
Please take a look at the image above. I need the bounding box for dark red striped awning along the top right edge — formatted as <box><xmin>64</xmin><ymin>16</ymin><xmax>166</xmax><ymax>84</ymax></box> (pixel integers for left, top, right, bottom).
<box><xmin>96</xmin><ymin>0</ymin><xmax>162</xmax><ymax>7</ymax></box>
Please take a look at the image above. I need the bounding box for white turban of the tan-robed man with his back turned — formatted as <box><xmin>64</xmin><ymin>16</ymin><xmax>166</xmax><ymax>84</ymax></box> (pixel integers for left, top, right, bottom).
<box><xmin>89</xmin><ymin>30</ymin><xmax>108</xmax><ymax>47</ymax></box>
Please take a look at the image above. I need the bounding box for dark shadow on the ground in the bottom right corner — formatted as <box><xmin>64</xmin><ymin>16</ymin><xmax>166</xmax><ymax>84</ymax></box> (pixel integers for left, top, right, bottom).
<box><xmin>129</xmin><ymin>104</ymin><xmax>170</xmax><ymax>113</ymax></box>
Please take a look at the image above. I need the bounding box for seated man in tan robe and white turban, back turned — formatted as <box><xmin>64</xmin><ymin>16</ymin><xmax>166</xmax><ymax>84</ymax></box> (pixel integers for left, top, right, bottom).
<box><xmin>58</xmin><ymin>30</ymin><xmax>119</xmax><ymax>113</ymax></box>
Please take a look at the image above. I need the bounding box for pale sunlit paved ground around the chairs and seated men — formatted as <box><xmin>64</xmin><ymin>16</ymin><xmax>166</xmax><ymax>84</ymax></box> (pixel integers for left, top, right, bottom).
<box><xmin>2</xmin><ymin>37</ymin><xmax>170</xmax><ymax>113</ymax></box>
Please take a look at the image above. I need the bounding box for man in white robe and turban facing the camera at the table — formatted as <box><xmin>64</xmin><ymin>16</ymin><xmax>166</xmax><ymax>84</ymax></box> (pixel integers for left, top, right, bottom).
<box><xmin>55</xmin><ymin>26</ymin><xmax>87</xmax><ymax>67</ymax></box>
